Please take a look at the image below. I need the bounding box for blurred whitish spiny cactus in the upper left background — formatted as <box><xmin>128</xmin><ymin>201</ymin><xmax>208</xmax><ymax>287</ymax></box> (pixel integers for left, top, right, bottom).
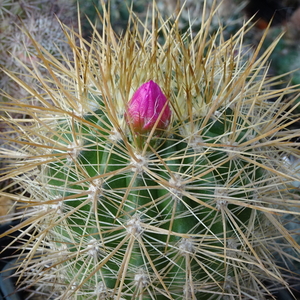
<box><xmin>0</xmin><ymin>0</ymin><xmax>75</xmax><ymax>101</ymax></box>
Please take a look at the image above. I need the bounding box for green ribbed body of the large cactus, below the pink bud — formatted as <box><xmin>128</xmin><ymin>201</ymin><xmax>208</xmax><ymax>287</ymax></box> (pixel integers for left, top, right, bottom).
<box><xmin>45</xmin><ymin>109</ymin><xmax>252</xmax><ymax>299</ymax></box>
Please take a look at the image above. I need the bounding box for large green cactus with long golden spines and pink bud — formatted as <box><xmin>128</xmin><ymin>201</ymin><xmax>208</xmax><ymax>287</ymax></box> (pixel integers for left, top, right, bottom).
<box><xmin>1</xmin><ymin>3</ymin><xmax>300</xmax><ymax>300</ymax></box>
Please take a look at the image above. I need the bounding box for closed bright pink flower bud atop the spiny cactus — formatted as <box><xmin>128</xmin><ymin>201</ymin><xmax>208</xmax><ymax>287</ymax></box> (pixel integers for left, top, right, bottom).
<box><xmin>125</xmin><ymin>80</ymin><xmax>171</xmax><ymax>133</ymax></box>
